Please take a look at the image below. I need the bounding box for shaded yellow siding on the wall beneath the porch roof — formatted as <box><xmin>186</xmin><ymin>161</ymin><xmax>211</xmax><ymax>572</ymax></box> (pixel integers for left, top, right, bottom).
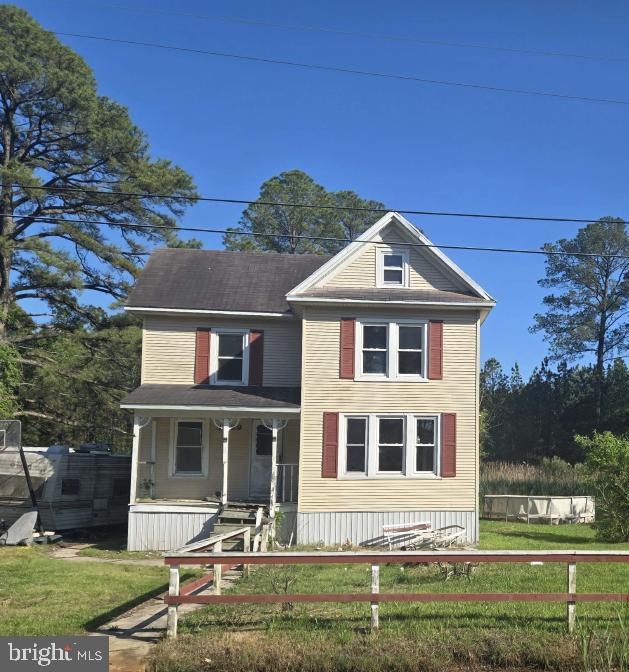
<box><xmin>151</xmin><ymin>418</ymin><xmax>299</xmax><ymax>500</ymax></box>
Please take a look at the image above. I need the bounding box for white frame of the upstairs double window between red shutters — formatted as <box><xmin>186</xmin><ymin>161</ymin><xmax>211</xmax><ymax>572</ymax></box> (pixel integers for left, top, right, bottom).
<box><xmin>354</xmin><ymin>320</ymin><xmax>428</xmax><ymax>382</ymax></box>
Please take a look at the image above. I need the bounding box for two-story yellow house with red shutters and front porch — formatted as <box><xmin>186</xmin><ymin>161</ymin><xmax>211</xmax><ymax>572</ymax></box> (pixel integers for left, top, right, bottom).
<box><xmin>122</xmin><ymin>213</ymin><xmax>495</xmax><ymax>549</ymax></box>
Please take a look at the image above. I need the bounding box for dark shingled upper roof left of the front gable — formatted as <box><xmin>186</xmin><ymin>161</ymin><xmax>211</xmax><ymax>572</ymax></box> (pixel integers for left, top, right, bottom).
<box><xmin>127</xmin><ymin>249</ymin><xmax>330</xmax><ymax>313</ymax></box>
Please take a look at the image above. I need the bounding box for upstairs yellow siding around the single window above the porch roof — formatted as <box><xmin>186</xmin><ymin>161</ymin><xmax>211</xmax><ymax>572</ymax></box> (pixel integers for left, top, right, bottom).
<box><xmin>142</xmin><ymin>316</ymin><xmax>301</xmax><ymax>387</ymax></box>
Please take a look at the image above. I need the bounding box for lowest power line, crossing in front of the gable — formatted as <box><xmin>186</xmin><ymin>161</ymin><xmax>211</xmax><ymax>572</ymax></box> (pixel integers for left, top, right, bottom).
<box><xmin>15</xmin><ymin>216</ymin><xmax>629</xmax><ymax>259</ymax></box>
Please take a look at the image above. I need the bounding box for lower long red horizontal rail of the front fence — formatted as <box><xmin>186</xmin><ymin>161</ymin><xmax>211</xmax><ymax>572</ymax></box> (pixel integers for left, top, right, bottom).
<box><xmin>164</xmin><ymin>593</ymin><xmax>629</xmax><ymax>604</ymax></box>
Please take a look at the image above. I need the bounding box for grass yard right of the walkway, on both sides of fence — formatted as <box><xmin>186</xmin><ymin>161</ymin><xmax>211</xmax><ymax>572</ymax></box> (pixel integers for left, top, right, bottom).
<box><xmin>153</xmin><ymin>521</ymin><xmax>629</xmax><ymax>672</ymax></box>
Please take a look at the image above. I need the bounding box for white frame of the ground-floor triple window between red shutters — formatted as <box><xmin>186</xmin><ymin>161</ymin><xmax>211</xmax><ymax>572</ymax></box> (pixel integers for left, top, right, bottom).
<box><xmin>337</xmin><ymin>412</ymin><xmax>442</xmax><ymax>480</ymax></box>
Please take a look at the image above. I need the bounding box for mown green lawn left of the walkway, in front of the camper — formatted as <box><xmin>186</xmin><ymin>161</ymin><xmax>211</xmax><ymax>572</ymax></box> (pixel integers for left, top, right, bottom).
<box><xmin>0</xmin><ymin>546</ymin><xmax>179</xmax><ymax>635</ymax></box>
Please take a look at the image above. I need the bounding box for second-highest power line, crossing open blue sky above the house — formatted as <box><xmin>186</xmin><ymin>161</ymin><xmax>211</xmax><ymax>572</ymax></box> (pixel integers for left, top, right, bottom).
<box><xmin>52</xmin><ymin>31</ymin><xmax>629</xmax><ymax>106</ymax></box>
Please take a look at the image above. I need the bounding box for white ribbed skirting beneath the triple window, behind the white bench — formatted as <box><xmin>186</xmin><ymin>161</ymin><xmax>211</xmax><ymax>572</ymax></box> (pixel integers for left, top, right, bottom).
<box><xmin>297</xmin><ymin>511</ymin><xmax>478</xmax><ymax>546</ymax></box>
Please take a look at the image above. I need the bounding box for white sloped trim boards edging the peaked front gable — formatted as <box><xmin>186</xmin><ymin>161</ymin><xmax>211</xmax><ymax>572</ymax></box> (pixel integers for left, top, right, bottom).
<box><xmin>287</xmin><ymin>212</ymin><xmax>495</xmax><ymax>305</ymax></box>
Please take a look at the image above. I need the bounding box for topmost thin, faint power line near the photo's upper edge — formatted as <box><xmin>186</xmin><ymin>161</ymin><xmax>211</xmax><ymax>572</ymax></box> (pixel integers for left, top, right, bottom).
<box><xmin>55</xmin><ymin>2</ymin><xmax>629</xmax><ymax>63</ymax></box>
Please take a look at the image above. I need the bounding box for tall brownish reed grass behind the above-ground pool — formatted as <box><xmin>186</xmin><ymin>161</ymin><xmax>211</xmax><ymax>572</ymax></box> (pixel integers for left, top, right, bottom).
<box><xmin>480</xmin><ymin>457</ymin><xmax>592</xmax><ymax>500</ymax></box>
